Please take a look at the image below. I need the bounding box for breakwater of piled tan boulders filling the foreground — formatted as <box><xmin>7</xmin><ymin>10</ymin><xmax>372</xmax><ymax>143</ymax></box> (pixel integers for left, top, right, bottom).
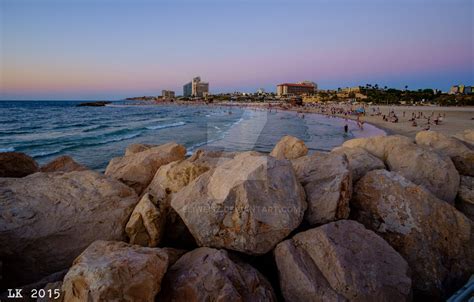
<box><xmin>0</xmin><ymin>133</ymin><xmax>474</xmax><ymax>301</ymax></box>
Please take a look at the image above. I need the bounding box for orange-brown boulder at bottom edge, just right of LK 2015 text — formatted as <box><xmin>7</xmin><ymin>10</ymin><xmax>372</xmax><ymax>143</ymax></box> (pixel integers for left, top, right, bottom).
<box><xmin>62</xmin><ymin>241</ymin><xmax>168</xmax><ymax>302</ymax></box>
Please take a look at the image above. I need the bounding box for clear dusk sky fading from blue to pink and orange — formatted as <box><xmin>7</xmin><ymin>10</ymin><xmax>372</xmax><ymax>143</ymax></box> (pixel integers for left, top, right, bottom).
<box><xmin>0</xmin><ymin>0</ymin><xmax>474</xmax><ymax>100</ymax></box>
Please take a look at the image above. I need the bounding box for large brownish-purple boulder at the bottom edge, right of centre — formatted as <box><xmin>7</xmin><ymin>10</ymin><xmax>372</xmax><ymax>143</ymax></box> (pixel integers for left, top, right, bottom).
<box><xmin>274</xmin><ymin>220</ymin><xmax>411</xmax><ymax>301</ymax></box>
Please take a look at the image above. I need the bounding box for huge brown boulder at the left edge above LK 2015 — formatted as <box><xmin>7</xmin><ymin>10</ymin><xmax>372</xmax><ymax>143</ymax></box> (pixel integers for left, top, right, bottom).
<box><xmin>0</xmin><ymin>171</ymin><xmax>138</xmax><ymax>286</ymax></box>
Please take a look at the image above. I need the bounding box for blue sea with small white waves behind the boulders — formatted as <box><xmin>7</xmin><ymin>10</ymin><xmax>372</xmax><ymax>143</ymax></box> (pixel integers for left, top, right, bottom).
<box><xmin>0</xmin><ymin>101</ymin><xmax>384</xmax><ymax>171</ymax></box>
